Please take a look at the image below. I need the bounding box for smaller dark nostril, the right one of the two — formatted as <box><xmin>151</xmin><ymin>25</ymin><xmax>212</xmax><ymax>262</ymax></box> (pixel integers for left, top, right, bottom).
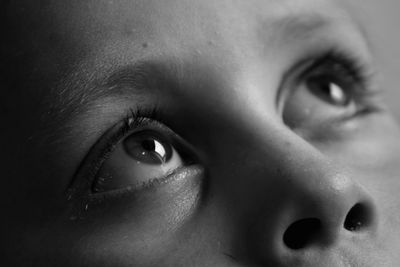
<box><xmin>344</xmin><ymin>203</ymin><xmax>372</xmax><ymax>232</ymax></box>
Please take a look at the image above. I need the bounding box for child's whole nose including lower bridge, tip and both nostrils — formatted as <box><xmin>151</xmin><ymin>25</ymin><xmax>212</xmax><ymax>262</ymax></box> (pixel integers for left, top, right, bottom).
<box><xmin>241</xmin><ymin>136</ymin><xmax>377</xmax><ymax>266</ymax></box>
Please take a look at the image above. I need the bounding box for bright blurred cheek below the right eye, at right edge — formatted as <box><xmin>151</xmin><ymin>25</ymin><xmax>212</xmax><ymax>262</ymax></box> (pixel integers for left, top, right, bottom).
<box><xmin>314</xmin><ymin>114</ymin><xmax>400</xmax><ymax>169</ymax></box>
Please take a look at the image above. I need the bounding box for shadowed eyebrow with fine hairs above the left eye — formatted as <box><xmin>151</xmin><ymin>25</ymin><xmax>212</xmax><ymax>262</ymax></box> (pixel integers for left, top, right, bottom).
<box><xmin>55</xmin><ymin>60</ymin><xmax>177</xmax><ymax>115</ymax></box>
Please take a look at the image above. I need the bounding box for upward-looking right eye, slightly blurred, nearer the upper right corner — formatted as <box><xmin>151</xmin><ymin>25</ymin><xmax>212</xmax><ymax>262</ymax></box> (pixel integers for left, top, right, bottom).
<box><xmin>282</xmin><ymin>52</ymin><xmax>368</xmax><ymax>128</ymax></box>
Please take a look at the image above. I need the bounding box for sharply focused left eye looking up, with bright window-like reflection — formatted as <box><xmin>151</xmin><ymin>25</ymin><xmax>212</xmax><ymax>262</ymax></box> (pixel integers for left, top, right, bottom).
<box><xmin>92</xmin><ymin>130</ymin><xmax>185</xmax><ymax>193</ymax></box>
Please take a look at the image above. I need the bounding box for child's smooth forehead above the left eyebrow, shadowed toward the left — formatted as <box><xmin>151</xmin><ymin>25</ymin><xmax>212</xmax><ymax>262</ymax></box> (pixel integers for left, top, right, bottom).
<box><xmin>9</xmin><ymin>0</ymin><xmax>366</xmax><ymax>95</ymax></box>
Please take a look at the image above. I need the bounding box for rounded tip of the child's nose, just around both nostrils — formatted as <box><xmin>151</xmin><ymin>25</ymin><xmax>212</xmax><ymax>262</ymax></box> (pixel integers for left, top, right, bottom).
<box><xmin>282</xmin><ymin>170</ymin><xmax>375</xmax><ymax>250</ymax></box>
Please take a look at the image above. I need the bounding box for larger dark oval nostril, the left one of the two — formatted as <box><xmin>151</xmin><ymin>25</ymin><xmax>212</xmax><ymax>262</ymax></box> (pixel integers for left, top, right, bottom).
<box><xmin>283</xmin><ymin>218</ymin><xmax>321</xmax><ymax>249</ymax></box>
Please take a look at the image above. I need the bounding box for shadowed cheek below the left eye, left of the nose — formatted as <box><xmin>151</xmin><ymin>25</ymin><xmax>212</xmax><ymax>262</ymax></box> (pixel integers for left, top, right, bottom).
<box><xmin>66</xmin><ymin>173</ymin><xmax>202</xmax><ymax>266</ymax></box>
